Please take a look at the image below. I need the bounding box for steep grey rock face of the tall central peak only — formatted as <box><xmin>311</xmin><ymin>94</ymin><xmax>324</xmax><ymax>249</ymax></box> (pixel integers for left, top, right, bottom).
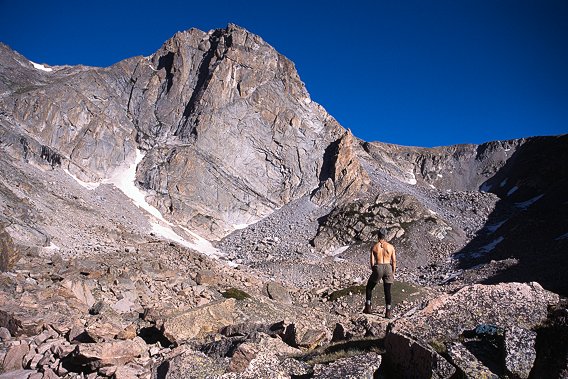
<box><xmin>129</xmin><ymin>26</ymin><xmax>343</xmax><ymax>237</ymax></box>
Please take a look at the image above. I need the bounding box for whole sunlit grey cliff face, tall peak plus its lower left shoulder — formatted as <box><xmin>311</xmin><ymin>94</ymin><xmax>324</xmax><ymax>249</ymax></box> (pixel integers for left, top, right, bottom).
<box><xmin>0</xmin><ymin>25</ymin><xmax>360</xmax><ymax>238</ymax></box>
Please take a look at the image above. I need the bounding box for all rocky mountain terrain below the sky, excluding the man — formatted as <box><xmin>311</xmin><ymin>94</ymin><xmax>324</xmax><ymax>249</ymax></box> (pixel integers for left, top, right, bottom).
<box><xmin>0</xmin><ymin>25</ymin><xmax>568</xmax><ymax>379</ymax></box>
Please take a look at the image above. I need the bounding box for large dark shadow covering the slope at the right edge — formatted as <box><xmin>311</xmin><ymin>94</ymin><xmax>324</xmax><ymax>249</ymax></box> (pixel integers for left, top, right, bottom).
<box><xmin>455</xmin><ymin>135</ymin><xmax>568</xmax><ymax>296</ymax></box>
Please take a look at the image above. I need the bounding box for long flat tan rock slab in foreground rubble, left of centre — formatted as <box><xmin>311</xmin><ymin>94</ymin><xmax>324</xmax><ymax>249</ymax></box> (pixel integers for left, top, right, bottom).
<box><xmin>163</xmin><ymin>299</ymin><xmax>236</xmax><ymax>344</ymax></box>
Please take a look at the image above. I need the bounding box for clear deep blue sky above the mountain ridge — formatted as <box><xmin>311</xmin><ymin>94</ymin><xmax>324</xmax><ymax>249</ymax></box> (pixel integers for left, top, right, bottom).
<box><xmin>0</xmin><ymin>0</ymin><xmax>568</xmax><ymax>146</ymax></box>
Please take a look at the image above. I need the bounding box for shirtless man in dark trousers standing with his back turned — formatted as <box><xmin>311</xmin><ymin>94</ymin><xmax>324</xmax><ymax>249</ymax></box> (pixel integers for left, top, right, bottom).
<box><xmin>363</xmin><ymin>229</ymin><xmax>396</xmax><ymax>318</ymax></box>
